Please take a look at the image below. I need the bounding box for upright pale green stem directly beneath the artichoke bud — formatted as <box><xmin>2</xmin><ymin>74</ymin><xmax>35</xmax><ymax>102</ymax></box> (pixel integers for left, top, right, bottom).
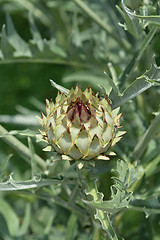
<box><xmin>78</xmin><ymin>168</ymin><xmax>118</xmax><ymax>240</ymax></box>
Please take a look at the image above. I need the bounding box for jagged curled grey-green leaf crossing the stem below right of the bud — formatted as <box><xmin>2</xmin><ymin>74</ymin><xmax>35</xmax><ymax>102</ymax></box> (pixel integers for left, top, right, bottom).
<box><xmin>84</xmin><ymin>160</ymin><xmax>138</xmax><ymax>213</ymax></box>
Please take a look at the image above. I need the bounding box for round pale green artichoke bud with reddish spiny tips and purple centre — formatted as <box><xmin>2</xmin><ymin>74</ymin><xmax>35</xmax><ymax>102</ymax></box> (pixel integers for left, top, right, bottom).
<box><xmin>37</xmin><ymin>86</ymin><xmax>124</xmax><ymax>165</ymax></box>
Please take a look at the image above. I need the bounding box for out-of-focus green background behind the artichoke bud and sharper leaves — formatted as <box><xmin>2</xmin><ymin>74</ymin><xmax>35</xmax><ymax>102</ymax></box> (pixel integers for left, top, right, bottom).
<box><xmin>0</xmin><ymin>0</ymin><xmax>160</xmax><ymax>240</ymax></box>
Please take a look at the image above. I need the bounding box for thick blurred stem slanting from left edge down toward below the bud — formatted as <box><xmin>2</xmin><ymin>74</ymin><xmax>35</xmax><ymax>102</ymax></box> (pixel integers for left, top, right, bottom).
<box><xmin>0</xmin><ymin>125</ymin><xmax>46</xmax><ymax>170</ymax></box>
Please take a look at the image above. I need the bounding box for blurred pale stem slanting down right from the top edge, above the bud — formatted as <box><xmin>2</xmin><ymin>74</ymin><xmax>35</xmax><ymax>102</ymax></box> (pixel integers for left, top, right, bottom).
<box><xmin>74</xmin><ymin>0</ymin><xmax>131</xmax><ymax>52</ymax></box>
